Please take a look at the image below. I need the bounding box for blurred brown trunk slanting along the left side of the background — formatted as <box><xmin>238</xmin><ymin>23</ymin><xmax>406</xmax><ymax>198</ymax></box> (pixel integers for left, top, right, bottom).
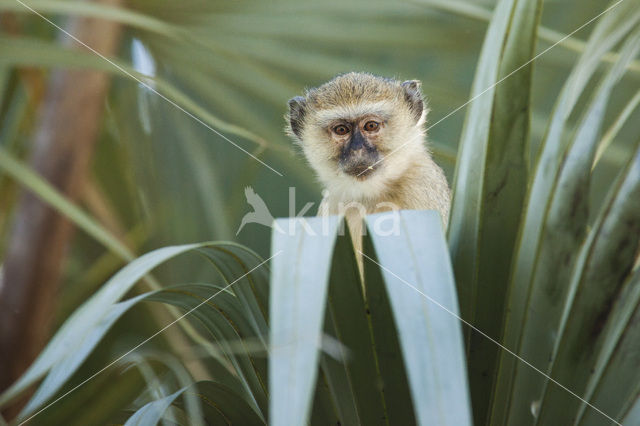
<box><xmin>0</xmin><ymin>0</ymin><xmax>120</xmax><ymax>410</ymax></box>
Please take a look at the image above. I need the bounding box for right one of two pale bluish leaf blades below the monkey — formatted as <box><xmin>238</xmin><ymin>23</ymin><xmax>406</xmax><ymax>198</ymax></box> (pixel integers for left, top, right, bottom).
<box><xmin>365</xmin><ymin>211</ymin><xmax>472</xmax><ymax>426</ymax></box>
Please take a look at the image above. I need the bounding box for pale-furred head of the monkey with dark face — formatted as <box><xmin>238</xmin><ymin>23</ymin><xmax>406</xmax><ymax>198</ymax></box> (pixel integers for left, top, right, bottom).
<box><xmin>286</xmin><ymin>73</ymin><xmax>427</xmax><ymax>196</ymax></box>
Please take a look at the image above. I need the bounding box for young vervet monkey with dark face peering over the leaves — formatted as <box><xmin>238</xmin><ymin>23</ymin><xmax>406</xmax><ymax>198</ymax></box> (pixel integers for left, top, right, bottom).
<box><xmin>286</xmin><ymin>72</ymin><xmax>451</xmax><ymax>273</ymax></box>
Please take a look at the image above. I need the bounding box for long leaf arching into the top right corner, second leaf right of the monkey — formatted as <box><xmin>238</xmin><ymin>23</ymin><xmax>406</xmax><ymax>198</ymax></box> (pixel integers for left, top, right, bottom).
<box><xmin>491</xmin><ymin>2</ymin><xmax>640</xmax><ymax>424</ymax></box>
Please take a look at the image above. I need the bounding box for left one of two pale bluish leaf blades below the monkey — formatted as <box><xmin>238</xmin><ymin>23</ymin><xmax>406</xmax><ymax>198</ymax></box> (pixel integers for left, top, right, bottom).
<box><xmin>269</xmin><ymin>216</ymin><xmax>342</xmax><ymax>426</ymax></box>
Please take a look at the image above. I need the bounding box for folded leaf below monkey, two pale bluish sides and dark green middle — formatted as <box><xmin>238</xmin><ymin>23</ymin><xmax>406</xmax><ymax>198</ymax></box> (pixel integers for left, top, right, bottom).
<box><xmin>270</xmin><ymin>211</ymin><xmax>471</xmax><ymax>425</ymax></box>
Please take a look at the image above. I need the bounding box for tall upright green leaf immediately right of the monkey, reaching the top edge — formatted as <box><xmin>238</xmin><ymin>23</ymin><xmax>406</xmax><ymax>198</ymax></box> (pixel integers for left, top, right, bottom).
<box><xmin>449</xmin><ymin>0</ymin><xmax>542</xmax><ymax>424</ymax></box>
